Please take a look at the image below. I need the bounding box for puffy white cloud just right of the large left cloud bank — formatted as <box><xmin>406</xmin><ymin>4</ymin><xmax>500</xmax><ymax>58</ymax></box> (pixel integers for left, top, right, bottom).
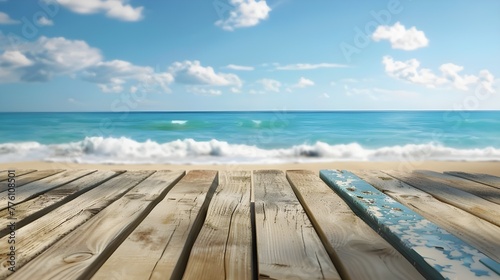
<box><xmin>169</xmin><ymin>60</ymin><xmax>242</xmax><ymax>87</ymax></box>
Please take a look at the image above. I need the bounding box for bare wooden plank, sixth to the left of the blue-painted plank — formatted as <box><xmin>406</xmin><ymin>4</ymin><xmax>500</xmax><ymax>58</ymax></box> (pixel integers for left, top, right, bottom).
<box><xmin>0</xmin><ymin>171</ymin><xmax>154</xmax><ymax>279</ymax></box>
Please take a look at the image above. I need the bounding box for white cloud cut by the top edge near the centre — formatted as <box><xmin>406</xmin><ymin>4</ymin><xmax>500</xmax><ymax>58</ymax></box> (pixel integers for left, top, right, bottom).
<box><xmin>215</xmin><ymin>0</ymin><xmax>271</xmax><ymax>31</ymax></box>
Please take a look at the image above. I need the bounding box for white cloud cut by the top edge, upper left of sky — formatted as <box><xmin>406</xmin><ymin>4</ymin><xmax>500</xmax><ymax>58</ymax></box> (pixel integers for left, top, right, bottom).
<box><xmin>54</xmin><ymin>0</ymin><xmax>144</xmax><ymax>21</ymax></box>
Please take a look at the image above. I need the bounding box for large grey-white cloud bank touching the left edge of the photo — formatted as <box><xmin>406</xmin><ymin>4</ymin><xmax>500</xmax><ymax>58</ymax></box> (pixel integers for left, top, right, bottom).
<box><xmin>0</xmin><ymin>33</ymin><xmax>174</xmax><ymax>92</ymax></box>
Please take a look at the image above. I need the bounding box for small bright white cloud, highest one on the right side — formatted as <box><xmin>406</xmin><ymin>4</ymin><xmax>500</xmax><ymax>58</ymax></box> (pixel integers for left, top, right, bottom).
<box><xmin>372</xmin><ymin>22</ymin><xmax>429</xmax><ymax>51</ymax></box>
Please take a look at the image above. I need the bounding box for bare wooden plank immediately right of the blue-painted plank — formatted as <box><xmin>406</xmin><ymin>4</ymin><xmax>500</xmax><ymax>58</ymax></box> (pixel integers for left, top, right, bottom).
<box><xmin>355</xmin><ymin>168</ymin><xmax>500</xmax><ymax>262</ymax></box>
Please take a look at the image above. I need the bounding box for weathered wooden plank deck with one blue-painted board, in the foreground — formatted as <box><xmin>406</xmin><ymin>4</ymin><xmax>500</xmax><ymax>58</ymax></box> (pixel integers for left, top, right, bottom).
<box><xmin>0</xmin><ymin>170</ymin><xmax>500</xmax><ymax>280</ymax></box>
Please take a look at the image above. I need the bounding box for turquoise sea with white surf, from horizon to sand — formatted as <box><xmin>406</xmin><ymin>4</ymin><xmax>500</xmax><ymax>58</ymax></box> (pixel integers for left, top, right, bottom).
<box><xmin>0</xmin><ymin>110</ymin><xmax>500</xmax><ymax>164</ymax></box>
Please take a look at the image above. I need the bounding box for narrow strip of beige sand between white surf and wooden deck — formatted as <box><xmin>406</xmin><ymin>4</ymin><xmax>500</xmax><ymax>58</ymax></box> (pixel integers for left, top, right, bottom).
<box><xmin>0</xmin><ymin>161</ymin><xmax>500</xmax><ymax>176</ymax></box>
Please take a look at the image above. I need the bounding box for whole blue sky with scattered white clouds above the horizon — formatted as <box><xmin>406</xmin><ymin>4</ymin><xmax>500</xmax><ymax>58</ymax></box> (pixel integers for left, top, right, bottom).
<box><xmin>0</xmin><ymin>0</ymin><xmax>500</xmax><ymax>112</ymax></box>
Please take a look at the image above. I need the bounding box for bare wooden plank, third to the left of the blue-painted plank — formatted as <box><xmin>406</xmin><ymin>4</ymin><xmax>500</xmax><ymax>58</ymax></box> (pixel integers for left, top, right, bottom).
<box><xmin>183</xmin><ymin>171</ymin><xmax>253</xmax><ymax>280</ymax></box>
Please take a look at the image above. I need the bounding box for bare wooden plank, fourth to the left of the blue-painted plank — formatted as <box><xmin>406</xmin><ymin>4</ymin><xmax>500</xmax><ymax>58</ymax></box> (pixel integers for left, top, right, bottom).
<box><xmin>92</xmin><ymin>170</ymin><xmax>217</xmax><ymax>279</ymax></box>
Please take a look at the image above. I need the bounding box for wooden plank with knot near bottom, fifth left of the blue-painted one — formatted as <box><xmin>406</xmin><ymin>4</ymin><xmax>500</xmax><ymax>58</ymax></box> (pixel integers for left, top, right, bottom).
<box><xmin>11</xmin><ymin>170</ymin><xmax>184</xmax><ymax>280</ymax></box>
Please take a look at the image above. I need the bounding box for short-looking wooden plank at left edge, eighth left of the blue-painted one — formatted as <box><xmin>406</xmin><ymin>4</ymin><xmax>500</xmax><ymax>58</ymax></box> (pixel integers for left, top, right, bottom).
<box><xmin>0</xmin><ymin>170</ymin><xmax>96</xmax><ymax>210</ymax></box>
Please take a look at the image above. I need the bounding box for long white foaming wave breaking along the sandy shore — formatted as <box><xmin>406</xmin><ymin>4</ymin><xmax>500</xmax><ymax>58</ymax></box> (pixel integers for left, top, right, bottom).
<box><xmin>0</xmin><ymin>137</ymin><xmax>500</xmax><ymax>164</ymax></box>
